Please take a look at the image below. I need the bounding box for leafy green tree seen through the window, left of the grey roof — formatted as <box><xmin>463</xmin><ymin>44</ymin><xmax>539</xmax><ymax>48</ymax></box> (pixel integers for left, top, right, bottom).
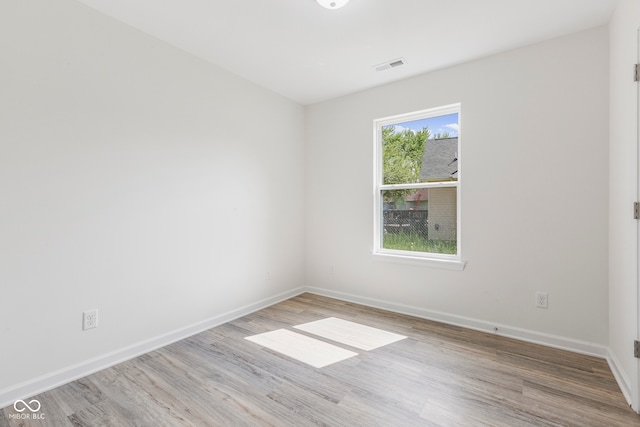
<box><xmin>382</xmin><ymin>126</ymin><xmax>431</xmax><ymax>201</ymax></box>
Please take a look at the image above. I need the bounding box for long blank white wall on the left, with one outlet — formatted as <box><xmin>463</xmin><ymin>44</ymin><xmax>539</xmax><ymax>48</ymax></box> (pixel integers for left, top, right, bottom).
<box><xmin>0</xmin><ymin>0</ymin><xmax>304</xmax><ymax>406</ymax></box>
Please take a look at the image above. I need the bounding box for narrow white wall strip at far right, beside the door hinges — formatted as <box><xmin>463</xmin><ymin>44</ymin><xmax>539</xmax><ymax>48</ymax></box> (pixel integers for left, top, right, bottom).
<box><xmin>609</xmin><ymin>0</ymin><xmax>640</xmax><ymax>411</ymax></box>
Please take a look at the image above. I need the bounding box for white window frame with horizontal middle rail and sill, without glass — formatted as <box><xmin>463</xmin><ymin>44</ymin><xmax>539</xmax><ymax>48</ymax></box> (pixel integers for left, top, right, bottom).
<box><xmin>373</xmin><ymin>103</ymin><xmax>465</xmax><ymax>270</ymax></box>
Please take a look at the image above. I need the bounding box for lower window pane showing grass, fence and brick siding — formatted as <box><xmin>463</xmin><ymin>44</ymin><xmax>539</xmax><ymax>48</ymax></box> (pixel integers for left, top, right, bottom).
<box><xmin>381</xmin><ymin>187</ymin><xmax>458</xmax><ymax>255</ymax></box>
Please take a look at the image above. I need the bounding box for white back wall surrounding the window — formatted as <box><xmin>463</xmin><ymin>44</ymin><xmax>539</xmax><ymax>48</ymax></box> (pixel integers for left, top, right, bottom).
<box><xmin>306</xmin><ymin>27</ymin><xmax>609</xmax><ymax>354</ymax></box>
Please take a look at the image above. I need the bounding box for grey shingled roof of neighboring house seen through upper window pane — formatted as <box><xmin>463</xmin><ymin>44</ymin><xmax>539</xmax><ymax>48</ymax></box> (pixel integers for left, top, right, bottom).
<box><xmin>420</xmin><ymin>137</ymin><xmax>458</xmax><ymax>182</ymax></box>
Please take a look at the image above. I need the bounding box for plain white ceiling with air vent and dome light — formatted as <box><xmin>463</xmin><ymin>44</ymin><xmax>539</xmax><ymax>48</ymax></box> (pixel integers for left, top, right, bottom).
<box><xmin>79</xmin><ymin>0</ymin><xmax>617</xmax><ymax>105</ymax></box>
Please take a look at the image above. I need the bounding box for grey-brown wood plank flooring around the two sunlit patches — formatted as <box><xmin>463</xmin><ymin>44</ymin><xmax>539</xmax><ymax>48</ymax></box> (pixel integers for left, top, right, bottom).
<box><xmin>0</xmin><ymin>294</ymin><xmax>640</xmax><ymax>427</ymax></box>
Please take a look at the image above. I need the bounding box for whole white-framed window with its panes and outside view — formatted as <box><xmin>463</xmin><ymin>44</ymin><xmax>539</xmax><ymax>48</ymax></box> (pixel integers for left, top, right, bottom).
<box><xmin>374</xmin><ymin>104</ymin><xmax>463</xmax><ymax>269</ymax></box>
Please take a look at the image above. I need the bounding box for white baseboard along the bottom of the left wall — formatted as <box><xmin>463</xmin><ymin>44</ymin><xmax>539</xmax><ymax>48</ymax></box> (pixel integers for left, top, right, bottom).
<box><xmin>0</xmin><ymin>288</ymin><xmax>304</xmax><ymax>408</ymax></box>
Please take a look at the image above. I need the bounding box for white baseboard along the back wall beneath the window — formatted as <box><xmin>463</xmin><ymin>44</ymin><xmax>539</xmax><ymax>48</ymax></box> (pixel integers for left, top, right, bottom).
<box><xmin>304</xmin><ymin>287</ymin><xmax>609</xmax><ymax>359</ymax></box>
